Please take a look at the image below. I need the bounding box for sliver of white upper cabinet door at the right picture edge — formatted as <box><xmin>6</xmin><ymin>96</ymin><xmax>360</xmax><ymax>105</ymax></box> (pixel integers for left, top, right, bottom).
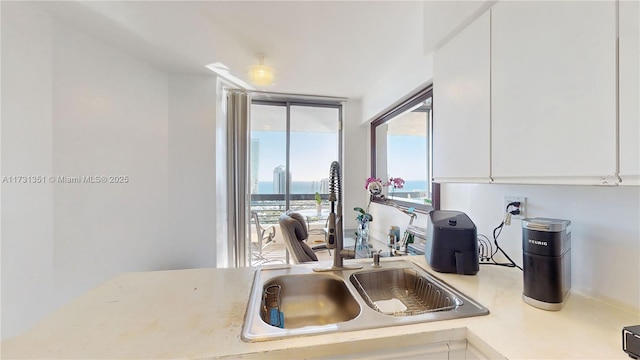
<box><xmin>619</xmin><ymin>1</ymin><xmax>640</xmax><ymax>185</ymax></box>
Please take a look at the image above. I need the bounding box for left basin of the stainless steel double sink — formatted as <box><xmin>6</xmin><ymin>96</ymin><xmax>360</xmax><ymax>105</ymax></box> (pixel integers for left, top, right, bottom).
<box><xmin>261</xmin><ymin>274</ymin><xmax>360</xmax><ymax>329</ymax></box>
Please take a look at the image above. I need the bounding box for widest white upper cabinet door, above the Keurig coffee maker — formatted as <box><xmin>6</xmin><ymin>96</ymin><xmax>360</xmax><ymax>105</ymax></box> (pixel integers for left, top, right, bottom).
<box><xmin>491</xmin><ymin>1</ymin><xmax>617</xmax><ymax>184</ymax></box>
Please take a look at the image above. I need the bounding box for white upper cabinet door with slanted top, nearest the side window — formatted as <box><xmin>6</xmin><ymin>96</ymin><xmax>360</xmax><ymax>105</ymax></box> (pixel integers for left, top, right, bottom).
<box><xmin>433</xmin><ymin>11</ymin><xmax>490</xmax><ymax>182</ymax></box>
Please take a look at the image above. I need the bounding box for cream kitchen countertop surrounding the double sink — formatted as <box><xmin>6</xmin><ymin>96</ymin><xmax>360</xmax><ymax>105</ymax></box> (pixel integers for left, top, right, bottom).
<box><xmin>0</xmin><ymin>256</ymin><xmax>640</xmax><ymax>359</ymax></box>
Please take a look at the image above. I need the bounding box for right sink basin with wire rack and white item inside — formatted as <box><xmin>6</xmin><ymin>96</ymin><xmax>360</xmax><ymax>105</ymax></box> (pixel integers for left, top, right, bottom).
<box><xmin>352</xmin><ymin>268</ymin><xmax>462</xmax><ymax>316</ymax></box>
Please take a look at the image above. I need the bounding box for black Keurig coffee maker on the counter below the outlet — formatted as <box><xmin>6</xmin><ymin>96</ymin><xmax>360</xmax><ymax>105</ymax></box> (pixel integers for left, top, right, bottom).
<box><xmin>522</xmin><ymin>218</ymin><xmax>571</xmax><ymax>310</ymax></box>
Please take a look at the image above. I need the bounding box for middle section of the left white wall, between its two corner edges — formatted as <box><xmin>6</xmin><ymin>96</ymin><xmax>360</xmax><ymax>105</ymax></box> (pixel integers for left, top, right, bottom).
<box><xmin>52</xmin><ymin>19</ymin><xmax>171</xmax><ymax>304</ymax></box>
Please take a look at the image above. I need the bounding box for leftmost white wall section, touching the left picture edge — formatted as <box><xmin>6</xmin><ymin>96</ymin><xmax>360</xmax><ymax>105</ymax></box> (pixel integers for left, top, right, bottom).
<box><xmin>0</xmin><ymin>3</ymin><xmax>54</xmax><ymax>338</ymax></box>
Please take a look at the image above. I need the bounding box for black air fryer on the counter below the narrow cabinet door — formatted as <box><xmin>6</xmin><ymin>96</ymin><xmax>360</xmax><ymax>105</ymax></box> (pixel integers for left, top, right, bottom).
<box><xmin>424</xmin><ymin>210</ymin><xmax>480</xmax><ymax>275</ymax></box>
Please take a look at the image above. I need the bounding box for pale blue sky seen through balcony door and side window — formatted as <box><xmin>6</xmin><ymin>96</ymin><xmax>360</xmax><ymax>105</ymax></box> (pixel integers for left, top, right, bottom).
<box><xmin>251</xmin><ymin>99</ymin><xmax>427</xmax><ymax>186</ymax></box>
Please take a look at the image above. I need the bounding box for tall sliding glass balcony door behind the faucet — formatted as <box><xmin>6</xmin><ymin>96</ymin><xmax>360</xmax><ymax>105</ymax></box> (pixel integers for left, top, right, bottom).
<box><xmin>250</xmin><ymin>100</ymin><xmax>342</xmax><ymax>262</ymax></box>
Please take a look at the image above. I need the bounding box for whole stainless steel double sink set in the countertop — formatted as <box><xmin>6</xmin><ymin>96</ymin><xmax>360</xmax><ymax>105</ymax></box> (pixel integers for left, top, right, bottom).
<box><xmin>242</xmin><ymin>260</ymin><xmax>489</xmax><ymax>341</ymax></box>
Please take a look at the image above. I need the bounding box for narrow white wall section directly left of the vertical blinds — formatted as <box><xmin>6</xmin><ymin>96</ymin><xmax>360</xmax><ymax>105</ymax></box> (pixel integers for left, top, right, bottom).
<box><xmin>167</xmin><ymin>75</ymin><xmax>217</xmax><ymax>268</ymax></box>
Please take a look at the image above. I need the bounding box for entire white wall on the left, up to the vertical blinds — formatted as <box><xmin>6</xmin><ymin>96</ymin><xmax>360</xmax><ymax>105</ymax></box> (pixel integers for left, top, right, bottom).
<box><xmin>1</xmin><ymin>2</ymin><xmax>216</xmax><ymax>339</ymax></box>
